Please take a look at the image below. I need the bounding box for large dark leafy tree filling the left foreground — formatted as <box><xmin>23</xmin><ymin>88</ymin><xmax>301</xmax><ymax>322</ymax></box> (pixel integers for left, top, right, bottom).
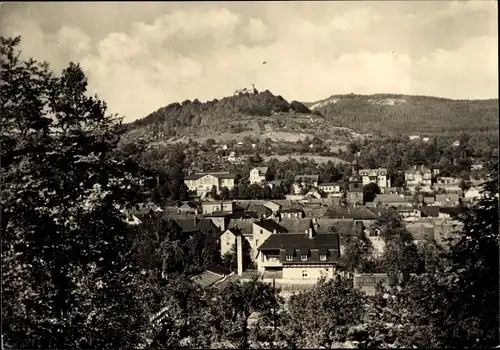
<box><xmin>0</xmin><ymin>37</ymin><xmax>147</xmax><ymax>348</ymax></box>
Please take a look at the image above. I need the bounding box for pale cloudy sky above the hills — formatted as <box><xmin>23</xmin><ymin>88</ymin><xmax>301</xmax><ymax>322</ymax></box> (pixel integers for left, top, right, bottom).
<box><xmin>0</xmin><ymin>0</ymin><xmax>498</xmax><ymax>121</ymax></box>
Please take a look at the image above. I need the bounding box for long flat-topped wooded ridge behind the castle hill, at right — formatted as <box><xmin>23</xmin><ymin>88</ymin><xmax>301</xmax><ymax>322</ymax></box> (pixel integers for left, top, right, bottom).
<box><xmin>305</xmin><ymin>94</ymin><xmax>499</xmax><ymax>136</ymax></box>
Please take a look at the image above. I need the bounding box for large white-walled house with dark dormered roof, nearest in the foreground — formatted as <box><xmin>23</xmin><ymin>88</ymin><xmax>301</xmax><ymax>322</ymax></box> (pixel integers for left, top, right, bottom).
<box><xmin>256</xmin><ymin>228</ymin><xmax>340</xmax><ymax>284</ymax></box>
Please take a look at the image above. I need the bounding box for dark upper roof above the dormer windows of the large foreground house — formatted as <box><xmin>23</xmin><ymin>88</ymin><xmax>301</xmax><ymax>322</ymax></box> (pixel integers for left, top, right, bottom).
<box><xmin>258</xmin><ymin>233</ymin><xmax>339</xmax><ymax>251</ymax></box>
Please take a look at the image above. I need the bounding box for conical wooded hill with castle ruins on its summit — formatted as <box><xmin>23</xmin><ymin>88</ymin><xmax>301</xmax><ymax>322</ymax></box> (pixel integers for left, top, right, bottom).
<box><xmin>125</xmin><ymin>91</ymin><xmax>370</xmax><ymax>144</ymax></box>
